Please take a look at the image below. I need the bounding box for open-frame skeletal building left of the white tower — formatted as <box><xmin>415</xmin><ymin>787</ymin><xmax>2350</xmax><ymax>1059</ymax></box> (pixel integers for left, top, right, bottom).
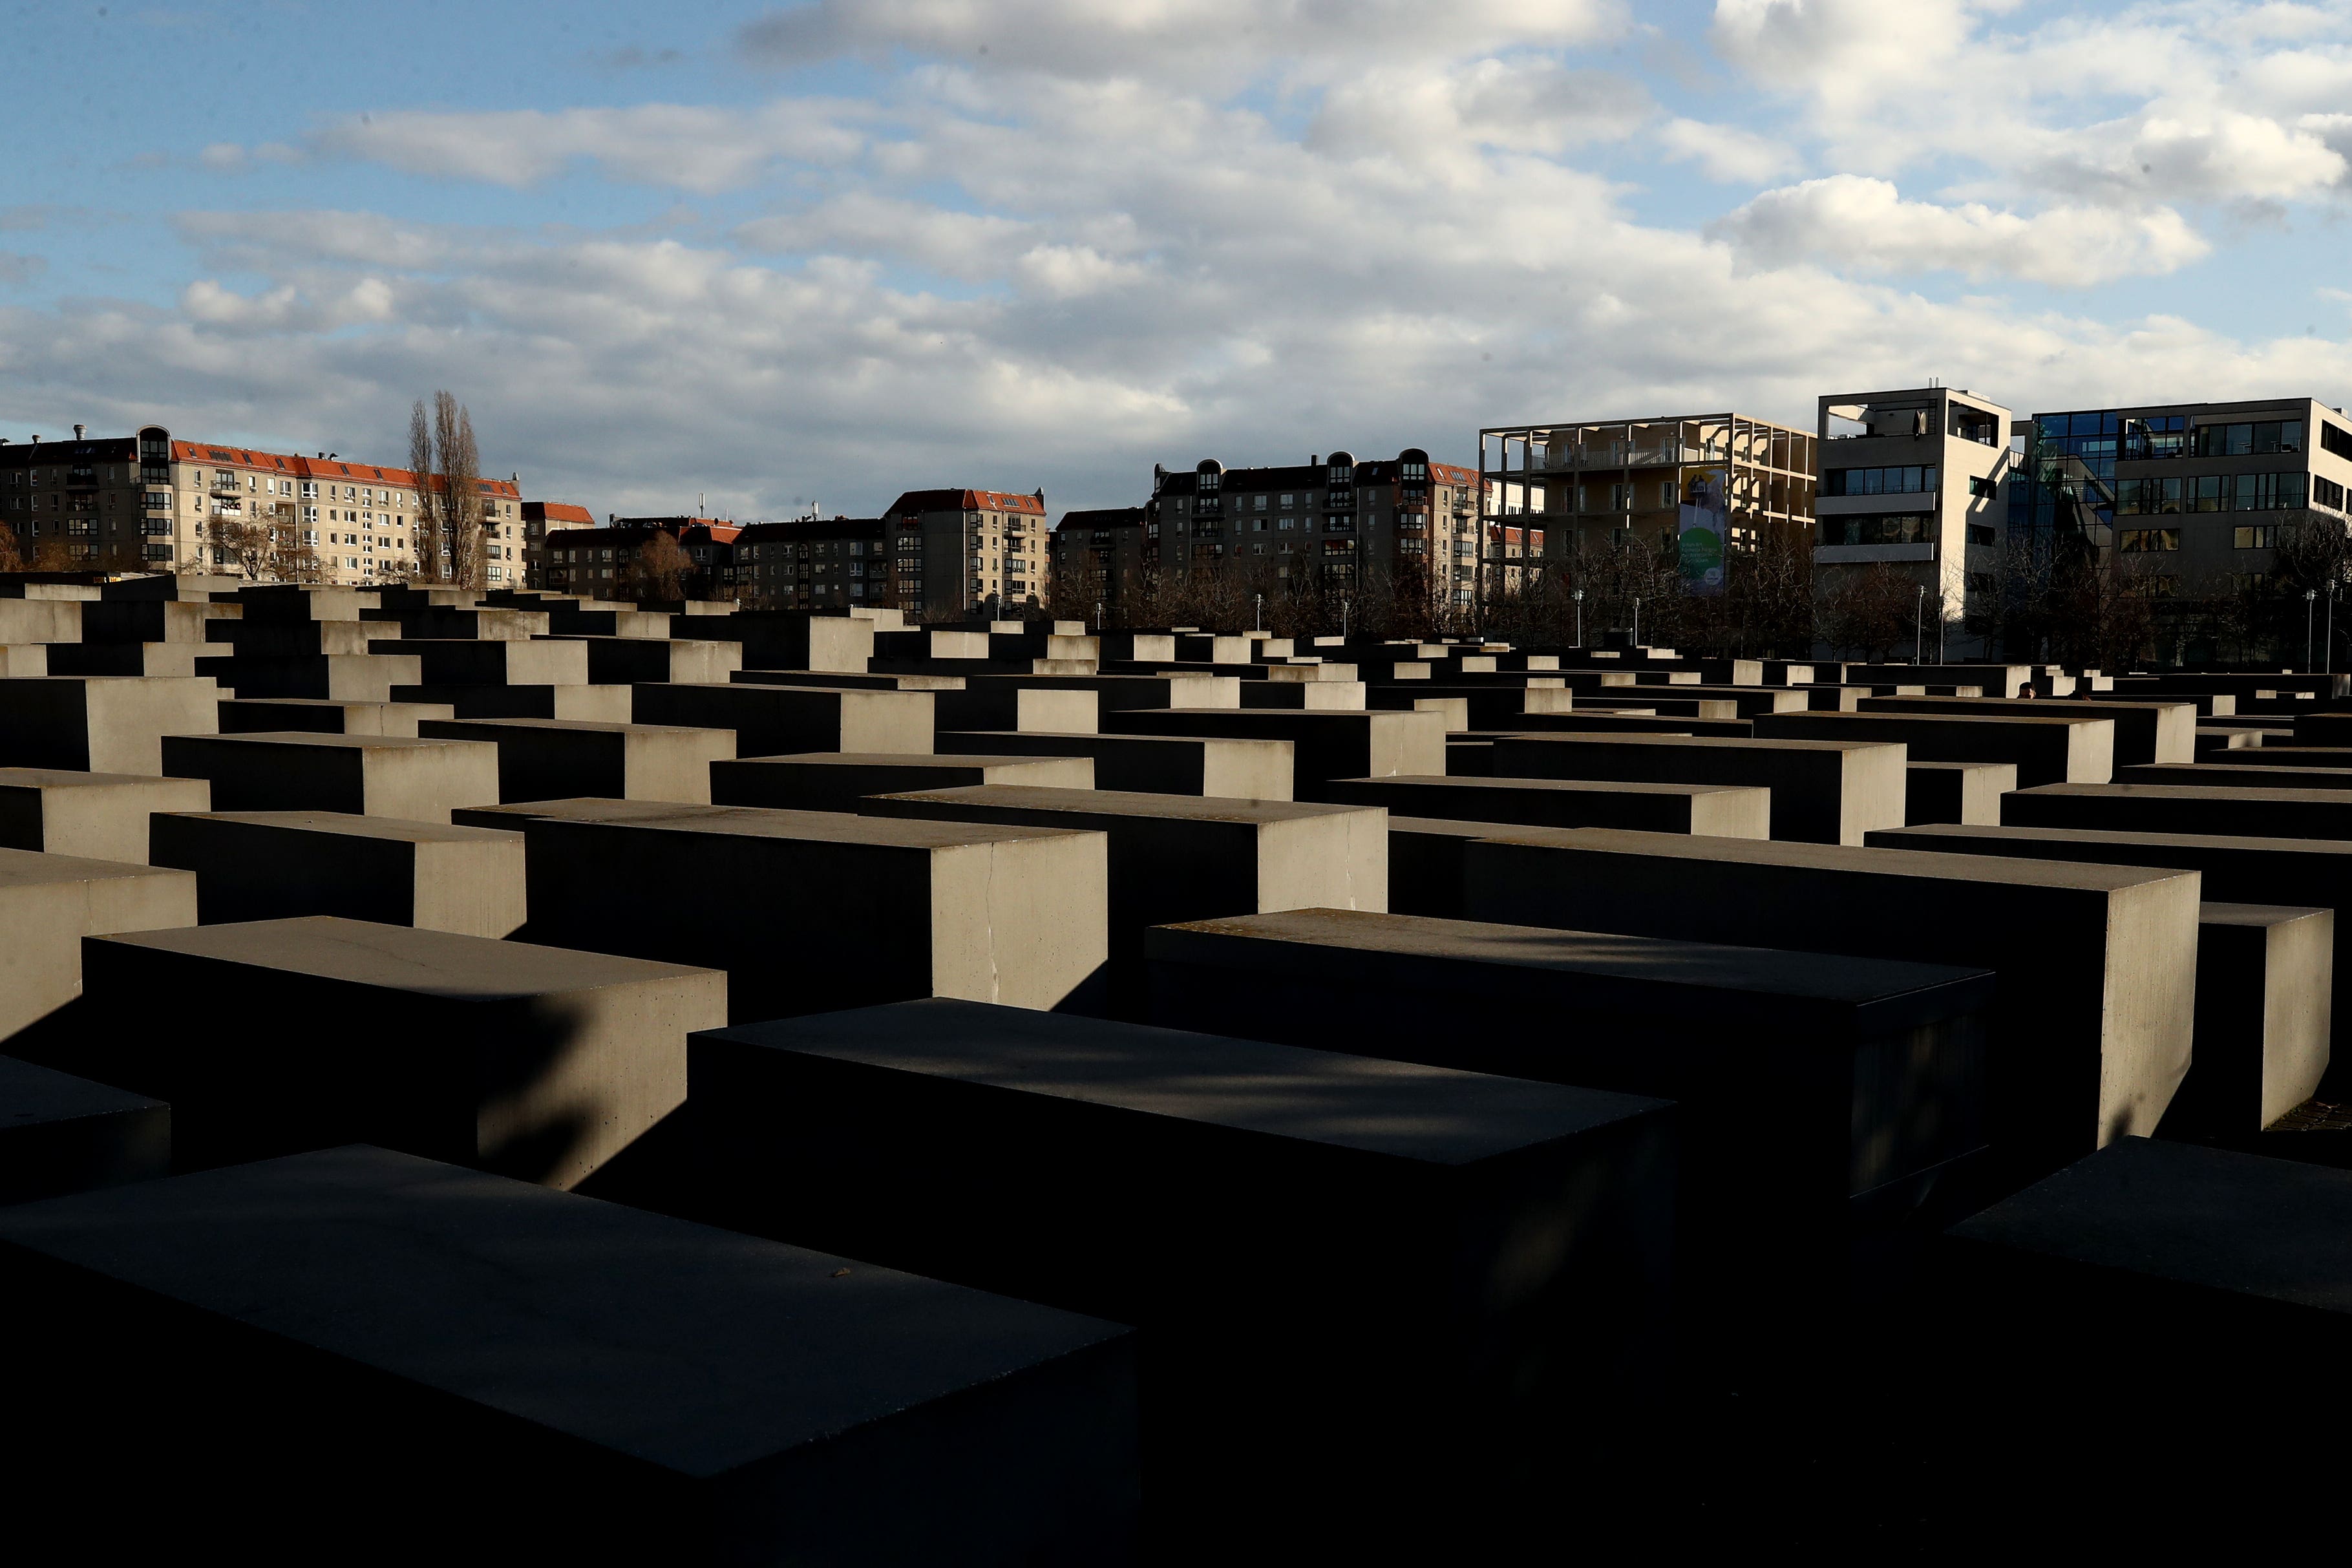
<box><xmin>1477</xmin><ymin>414</ymin><xmax>1818</xmax><ymax>588</ymax></box>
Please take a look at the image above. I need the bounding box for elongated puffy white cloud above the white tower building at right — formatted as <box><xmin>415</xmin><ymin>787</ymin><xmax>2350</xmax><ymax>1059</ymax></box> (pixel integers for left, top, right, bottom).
<box><xmin>1710</xmin><ymin>174</ymin><xmax>2211</xmax><ymax>287</ymax></box>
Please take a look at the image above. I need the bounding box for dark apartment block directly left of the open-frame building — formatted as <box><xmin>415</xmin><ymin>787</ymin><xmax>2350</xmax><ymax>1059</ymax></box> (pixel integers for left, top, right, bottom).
<box><xmin>1141</xmin><ymin>447</ymin><xmax>1479</xmax><ymax>604</ymax></box>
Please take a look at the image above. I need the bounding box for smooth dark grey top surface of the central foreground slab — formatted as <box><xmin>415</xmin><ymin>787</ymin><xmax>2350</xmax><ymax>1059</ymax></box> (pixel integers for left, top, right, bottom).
<box><xmin>694</xmin><ymin>999</ymin><xmax>1665</xmax><ymax>1166</ymax></box>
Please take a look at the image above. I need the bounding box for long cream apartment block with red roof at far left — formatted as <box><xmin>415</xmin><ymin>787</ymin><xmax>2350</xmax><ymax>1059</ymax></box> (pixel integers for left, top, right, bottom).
<box><xmin>0</xmin><ymin>425</ymin><xmax>522</xmax><ymax>588</ymax></box>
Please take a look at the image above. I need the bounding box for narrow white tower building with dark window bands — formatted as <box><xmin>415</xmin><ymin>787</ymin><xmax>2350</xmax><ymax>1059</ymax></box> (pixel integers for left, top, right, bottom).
<box><xmin>1814</xmin><ymin>385</ymin><xmax>2013</xmax><ymax>658</ymax></box>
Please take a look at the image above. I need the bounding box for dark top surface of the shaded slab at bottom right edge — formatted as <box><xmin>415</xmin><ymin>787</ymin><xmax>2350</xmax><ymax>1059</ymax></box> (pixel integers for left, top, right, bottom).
<box><xmin>1950</xmin><ymin>1138</ymin><xmax>2352</xmax><ymax>1312</ymax></box>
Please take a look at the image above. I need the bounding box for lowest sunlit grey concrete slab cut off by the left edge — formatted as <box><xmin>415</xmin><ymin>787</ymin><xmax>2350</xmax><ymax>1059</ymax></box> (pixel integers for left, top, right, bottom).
<box><xmin>0</xmin><ymin>849</ymin><xmax>195</xmax><ymax>1039</ymax></box>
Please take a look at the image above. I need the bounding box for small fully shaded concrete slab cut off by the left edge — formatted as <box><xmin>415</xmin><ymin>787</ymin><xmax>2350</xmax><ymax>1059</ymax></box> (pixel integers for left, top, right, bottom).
<box><xmin>0</xmin><ymin>1055</ymin><xmax>172</xmax><ymax>1206</ymax></box>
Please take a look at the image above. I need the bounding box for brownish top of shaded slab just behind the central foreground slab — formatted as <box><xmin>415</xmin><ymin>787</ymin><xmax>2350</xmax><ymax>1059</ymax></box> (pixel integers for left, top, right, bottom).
<box><xmin>1155</xmin><ymin>910</ymin><xmax>1992</xmax><ymax>1008</ymax></box>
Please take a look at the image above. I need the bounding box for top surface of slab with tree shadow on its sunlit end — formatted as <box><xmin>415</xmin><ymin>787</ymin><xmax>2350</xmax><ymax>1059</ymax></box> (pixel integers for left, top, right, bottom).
<box><xmin>103</xmin><ymin>915</ymin><xmax>710</xmax><ymax>1001</ymax></box>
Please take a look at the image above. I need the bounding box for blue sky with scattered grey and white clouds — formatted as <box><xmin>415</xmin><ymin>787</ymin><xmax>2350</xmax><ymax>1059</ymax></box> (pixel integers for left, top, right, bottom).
<box><xmin>0</xmin><ymin>0</ymin><xmax>2352</xmax><ymax>517</ymax></box>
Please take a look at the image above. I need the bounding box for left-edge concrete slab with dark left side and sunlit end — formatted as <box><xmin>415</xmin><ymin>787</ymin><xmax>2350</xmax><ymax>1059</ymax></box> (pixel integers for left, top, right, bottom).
<box><xmin>0</xmin><ymin>675</ymin><xmax>221</xmax><ymax>774</ymax></box>
